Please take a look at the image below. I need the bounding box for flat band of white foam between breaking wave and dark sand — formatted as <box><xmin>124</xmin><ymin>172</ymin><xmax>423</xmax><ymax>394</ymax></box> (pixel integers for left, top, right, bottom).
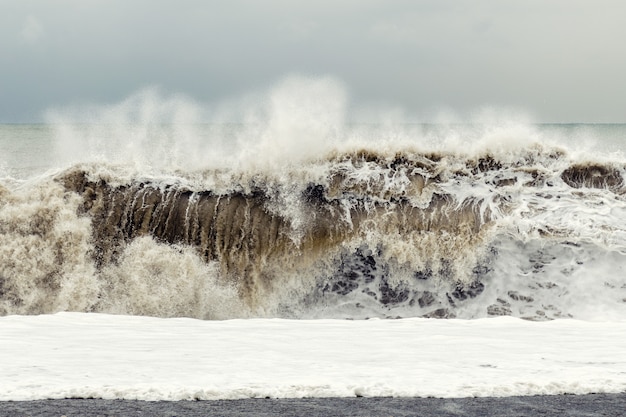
<box><xmin>0</xmin><ymin>313</ymin><xmax>626</xmax><ymax>400</ymax></box>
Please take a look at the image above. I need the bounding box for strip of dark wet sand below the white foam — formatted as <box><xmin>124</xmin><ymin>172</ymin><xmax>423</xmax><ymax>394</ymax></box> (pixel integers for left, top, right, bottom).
<box><xmin>0</xmin><ymin>393</ymin><xmax>626</xmax><ymax>417</ymax></box>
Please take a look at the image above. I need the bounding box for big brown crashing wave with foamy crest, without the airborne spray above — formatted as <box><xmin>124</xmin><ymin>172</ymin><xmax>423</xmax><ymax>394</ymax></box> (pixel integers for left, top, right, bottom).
<box><xmin>0</xmin><ymin>145</ymin><xmax>626</xmax><ymax>319</ymax></box>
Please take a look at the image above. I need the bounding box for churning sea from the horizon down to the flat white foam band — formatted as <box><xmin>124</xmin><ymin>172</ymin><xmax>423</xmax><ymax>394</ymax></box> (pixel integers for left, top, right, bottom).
<box><xmin>0</xmin><ymin>120</ymin><xmax>626</xmax><ymax>320</ymax></box>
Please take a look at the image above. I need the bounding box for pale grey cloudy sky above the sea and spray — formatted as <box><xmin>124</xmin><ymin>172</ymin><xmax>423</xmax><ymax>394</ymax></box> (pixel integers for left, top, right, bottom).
<box><xmin>0</xmin><ymin>0</ymin><xmax>626</xmax><ymax>122</ymax></box>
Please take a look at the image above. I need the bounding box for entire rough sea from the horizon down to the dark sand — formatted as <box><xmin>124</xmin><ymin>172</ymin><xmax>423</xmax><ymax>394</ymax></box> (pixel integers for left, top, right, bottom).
<box><xmin>0</xmin><ymin>118</ymin><xmax>626</xmax><ymax>400</ymax></box>
